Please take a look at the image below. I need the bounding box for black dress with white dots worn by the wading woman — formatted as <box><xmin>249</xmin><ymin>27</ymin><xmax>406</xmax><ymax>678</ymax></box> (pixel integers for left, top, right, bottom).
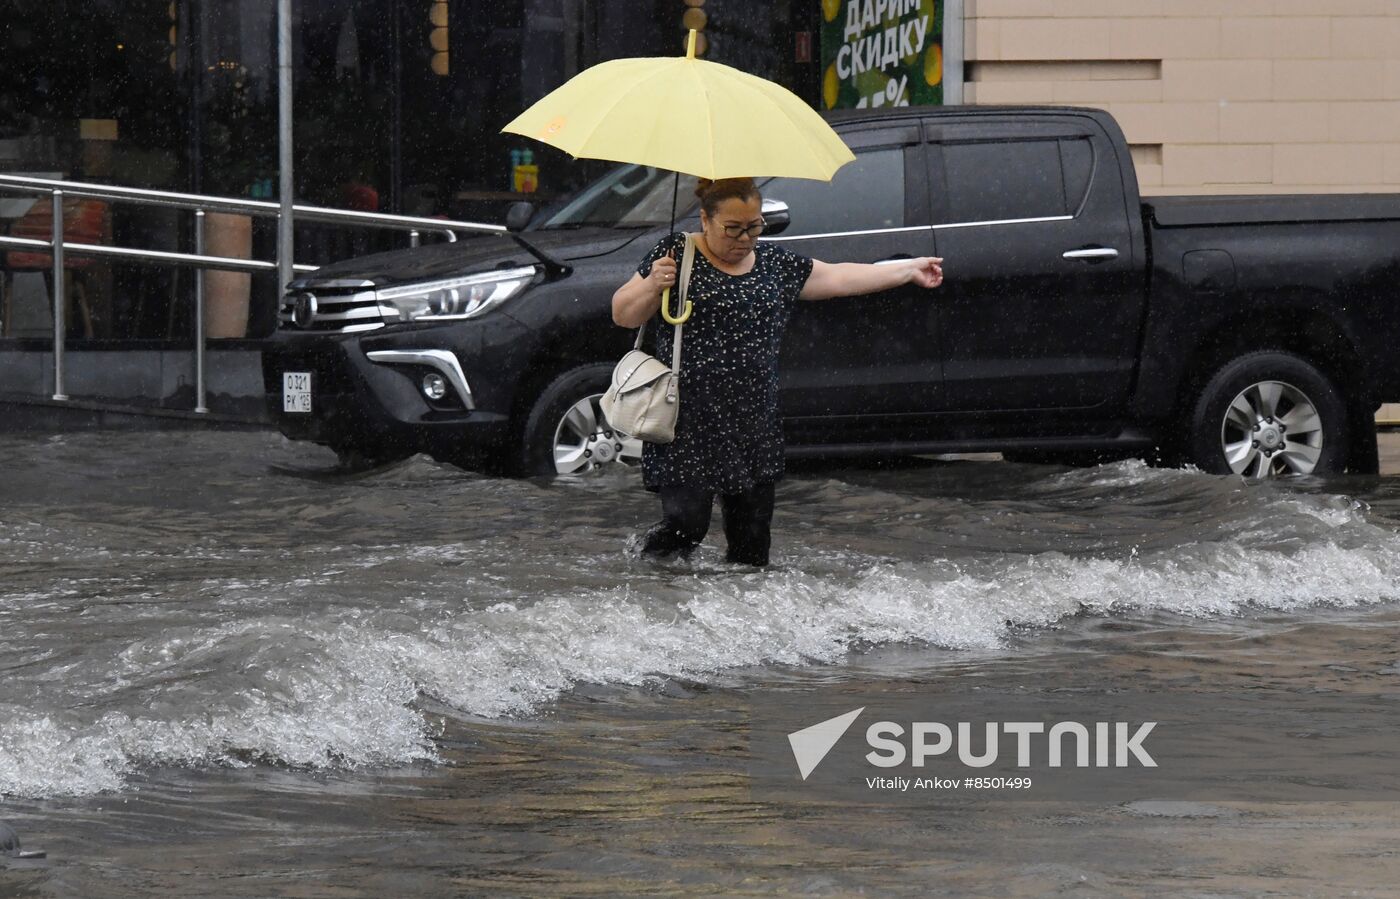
<box><xmin>637</xmin><ymin>232</ymin><xmax>812</xmax><ymax>493</ymax></box>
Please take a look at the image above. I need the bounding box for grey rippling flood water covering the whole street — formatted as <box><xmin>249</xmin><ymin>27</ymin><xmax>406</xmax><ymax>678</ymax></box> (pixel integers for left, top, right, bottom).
<box><xmin>0</xmin><ymin>433</ymin><xmax>1400</xmax><ymax>896</ymax></box>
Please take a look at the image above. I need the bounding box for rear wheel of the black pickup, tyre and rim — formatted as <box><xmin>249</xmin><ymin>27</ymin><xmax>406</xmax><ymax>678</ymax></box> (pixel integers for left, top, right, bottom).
<box><xmin>1189</xmin><ymin>350</ymin><xmax>1348</xmax><ymax>480</ymax></box>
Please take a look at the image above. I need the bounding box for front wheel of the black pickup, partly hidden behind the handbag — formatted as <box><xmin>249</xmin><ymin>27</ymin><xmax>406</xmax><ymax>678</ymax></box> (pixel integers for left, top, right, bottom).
<box><xmin>519</xmin><ymin>364</ymin><xmax>641</xmax><ymax>475</ymax></box>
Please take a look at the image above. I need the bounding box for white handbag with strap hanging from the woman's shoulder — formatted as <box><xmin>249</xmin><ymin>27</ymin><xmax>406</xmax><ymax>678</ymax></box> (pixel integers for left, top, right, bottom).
<box><xmin>598</xmin><ymin>234</ymin><xmax>696</xmax><ymax>444</ymax></box>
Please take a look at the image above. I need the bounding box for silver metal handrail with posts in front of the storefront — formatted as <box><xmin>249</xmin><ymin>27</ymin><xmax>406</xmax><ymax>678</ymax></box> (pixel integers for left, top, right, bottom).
<box><xmin>0</xmin><ymin>175</ymin><xmax>507</xmax><ymax>413</ymax></box>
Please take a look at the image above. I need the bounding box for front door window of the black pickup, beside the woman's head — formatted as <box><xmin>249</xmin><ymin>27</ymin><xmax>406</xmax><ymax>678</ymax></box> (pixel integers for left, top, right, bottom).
<box><xmin>759</xmin><ymin>147</ymin><xmax>904</xmax><ymax>237</ymax></box>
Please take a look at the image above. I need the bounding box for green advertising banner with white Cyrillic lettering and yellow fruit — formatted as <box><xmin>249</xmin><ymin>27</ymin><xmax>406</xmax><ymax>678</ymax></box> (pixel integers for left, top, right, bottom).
<box><xmin>822</xmin><ymin>0</ymin><xmax>944</xmax><ymax>109</ymax></box>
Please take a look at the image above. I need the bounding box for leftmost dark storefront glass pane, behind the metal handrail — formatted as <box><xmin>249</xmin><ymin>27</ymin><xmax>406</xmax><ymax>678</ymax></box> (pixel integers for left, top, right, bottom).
<box><xmin>0</xmin><ymin>0</ymin><xmax>188</xmax><ymax>339</ymax></box>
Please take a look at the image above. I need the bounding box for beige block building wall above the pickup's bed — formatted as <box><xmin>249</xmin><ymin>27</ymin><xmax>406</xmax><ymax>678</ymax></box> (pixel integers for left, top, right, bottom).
<box><xmin>965</xmin><ymin>0</ymin><xmax>1400</xmax><ymax>195</ymax></box>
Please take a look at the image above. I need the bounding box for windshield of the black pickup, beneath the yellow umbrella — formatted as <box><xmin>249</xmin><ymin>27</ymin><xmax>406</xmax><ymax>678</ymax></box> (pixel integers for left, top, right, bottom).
<box><xmin>540</xmin><ymin>164</ymin><xmax>696</xmax><ymax>228</ymax></box>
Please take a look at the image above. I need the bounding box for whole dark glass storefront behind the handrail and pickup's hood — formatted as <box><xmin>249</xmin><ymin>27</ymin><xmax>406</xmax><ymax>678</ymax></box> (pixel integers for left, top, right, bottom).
<box><xmin>0</xmin><ymin>0</ymin><xmax>811</xmax><ymax>343</ymax></box>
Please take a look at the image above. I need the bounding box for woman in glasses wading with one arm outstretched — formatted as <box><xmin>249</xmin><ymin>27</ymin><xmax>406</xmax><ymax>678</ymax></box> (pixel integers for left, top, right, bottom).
<box><xmin>612</xmin><ymin>178</ymin><xmax>944</xmax><ymax>566</ymax></box>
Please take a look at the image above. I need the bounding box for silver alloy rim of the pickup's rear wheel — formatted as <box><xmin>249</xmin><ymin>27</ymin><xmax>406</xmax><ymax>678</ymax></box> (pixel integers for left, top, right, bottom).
<box><xmin>1221</xmin><ymin>381</ymin><xmax>1323</xmax><ymax>480</ymax></box>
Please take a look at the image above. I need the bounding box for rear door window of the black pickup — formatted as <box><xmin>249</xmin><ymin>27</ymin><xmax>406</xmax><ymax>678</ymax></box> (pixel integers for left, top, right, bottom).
<box><xmin>946</xmin><ymin>140</ymin><xmax>1074</xmax><ymax>221</ymax></box>
